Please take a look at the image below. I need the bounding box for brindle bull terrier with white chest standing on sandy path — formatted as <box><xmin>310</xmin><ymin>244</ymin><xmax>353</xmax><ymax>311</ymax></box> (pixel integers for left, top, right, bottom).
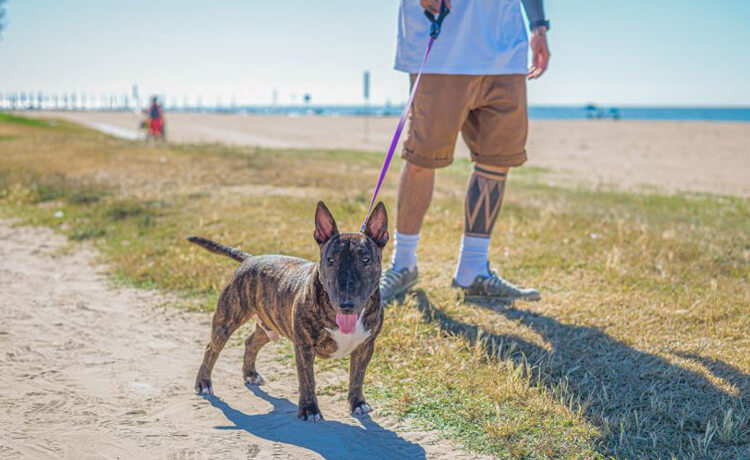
<box><xmin>188</xmin><ymin>201</ymin><xmax>388</xmax><ymax>421</ymax></box>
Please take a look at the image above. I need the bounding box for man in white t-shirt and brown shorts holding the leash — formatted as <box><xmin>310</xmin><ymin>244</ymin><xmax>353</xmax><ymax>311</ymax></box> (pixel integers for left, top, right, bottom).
<box><xmin>380</xmin><ymin>0</ymin><xmax>550</xmax><ymax>302</ymax></box>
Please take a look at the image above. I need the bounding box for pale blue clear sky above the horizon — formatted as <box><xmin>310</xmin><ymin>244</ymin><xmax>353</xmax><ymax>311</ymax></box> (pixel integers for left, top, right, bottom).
<box><xmin>0</xmin><ymin>0</ymin><xmax>750</xmax><ymax>106</ymax></box>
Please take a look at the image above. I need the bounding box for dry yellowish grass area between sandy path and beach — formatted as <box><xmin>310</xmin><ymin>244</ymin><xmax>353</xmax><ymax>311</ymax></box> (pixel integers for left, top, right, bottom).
<box><xmin>0</xmin><ymin>114</ymin><xmax>750</xmax><ymax>458</ymax></box>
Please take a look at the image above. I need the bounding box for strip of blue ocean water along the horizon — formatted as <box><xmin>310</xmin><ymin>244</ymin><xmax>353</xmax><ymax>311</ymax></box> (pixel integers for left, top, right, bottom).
<box><xmin>222</xmin><ymin>105</ymin><xmax>750</xmax><ymax>122</ymax></box>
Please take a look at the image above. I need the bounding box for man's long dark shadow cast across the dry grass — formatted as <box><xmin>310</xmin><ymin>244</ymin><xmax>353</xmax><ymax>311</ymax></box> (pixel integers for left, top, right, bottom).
<box><xmin>413</xmin><ymin>290</ymin><xmax>750</xmax><ymax>458</ymax></box>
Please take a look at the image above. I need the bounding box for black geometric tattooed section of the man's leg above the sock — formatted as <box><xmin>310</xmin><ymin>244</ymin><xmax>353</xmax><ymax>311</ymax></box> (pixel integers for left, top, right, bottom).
<box><xmin>464</xmin><ymin>165</ymin><xmax>506</xmax><ymax>237</ymax></box>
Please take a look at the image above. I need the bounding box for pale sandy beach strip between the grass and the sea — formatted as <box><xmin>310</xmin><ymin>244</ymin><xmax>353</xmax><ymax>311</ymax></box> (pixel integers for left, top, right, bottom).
<box><xmin>44</xmin><ymin>112</ymin><xmax>750</xmax><ymax>197</ymax></box>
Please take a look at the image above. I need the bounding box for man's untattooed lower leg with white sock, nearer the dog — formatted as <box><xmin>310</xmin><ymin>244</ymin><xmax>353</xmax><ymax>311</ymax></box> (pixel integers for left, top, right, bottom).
<box><xmin>391</xmin><ymin>161</ymin><xmax>435</xmax><ymax>271</ymax></box>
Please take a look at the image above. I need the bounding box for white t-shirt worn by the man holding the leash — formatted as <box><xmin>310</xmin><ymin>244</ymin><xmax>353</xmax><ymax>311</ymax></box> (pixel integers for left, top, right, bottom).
<box><xmin>395</xmin><ymin>0</ymin><xmax>529</xmax><ymax>75</ymax></box>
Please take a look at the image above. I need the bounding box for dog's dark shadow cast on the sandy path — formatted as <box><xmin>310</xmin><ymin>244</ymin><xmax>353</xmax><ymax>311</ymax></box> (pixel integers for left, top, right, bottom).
<box><xmin>205</xmin><ymin>385</ymin><xmax>426</xmax><ymax>459</ymax></box>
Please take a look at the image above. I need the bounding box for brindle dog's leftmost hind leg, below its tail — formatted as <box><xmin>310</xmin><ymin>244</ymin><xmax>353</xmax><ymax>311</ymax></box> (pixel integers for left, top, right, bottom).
<box><xmin>195</xmin><ymin>288</ymin><xmax>250</xmax><ymax>395</ymax></box>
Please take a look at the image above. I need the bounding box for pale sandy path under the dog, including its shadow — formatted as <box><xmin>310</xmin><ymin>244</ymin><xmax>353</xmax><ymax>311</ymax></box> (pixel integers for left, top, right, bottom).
<box><xmin>0</xmin><ymin>221</ymin><xmax>482</xmax><ymax>459</ymax></box>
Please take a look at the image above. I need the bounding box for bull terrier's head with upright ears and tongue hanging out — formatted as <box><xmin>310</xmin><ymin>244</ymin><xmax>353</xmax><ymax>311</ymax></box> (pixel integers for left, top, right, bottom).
<box><xmin>315</xmin><ymin>201</ymin><xmax>388</xmax><ymax>334</ymax></box>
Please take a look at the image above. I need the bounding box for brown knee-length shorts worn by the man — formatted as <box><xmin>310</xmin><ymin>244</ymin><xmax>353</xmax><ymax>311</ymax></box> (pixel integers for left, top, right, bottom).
<box><xmin>401</xmin><ymin>74</ymin><xmax>528</xmax><ymax>168</ymax></box>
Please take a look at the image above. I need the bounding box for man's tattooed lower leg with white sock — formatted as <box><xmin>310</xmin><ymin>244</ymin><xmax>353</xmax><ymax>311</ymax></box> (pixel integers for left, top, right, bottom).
<box><xmin>454</xmin><ymin>163</ymin><xmax>508</xmax><ymax>287</ymax></box>
